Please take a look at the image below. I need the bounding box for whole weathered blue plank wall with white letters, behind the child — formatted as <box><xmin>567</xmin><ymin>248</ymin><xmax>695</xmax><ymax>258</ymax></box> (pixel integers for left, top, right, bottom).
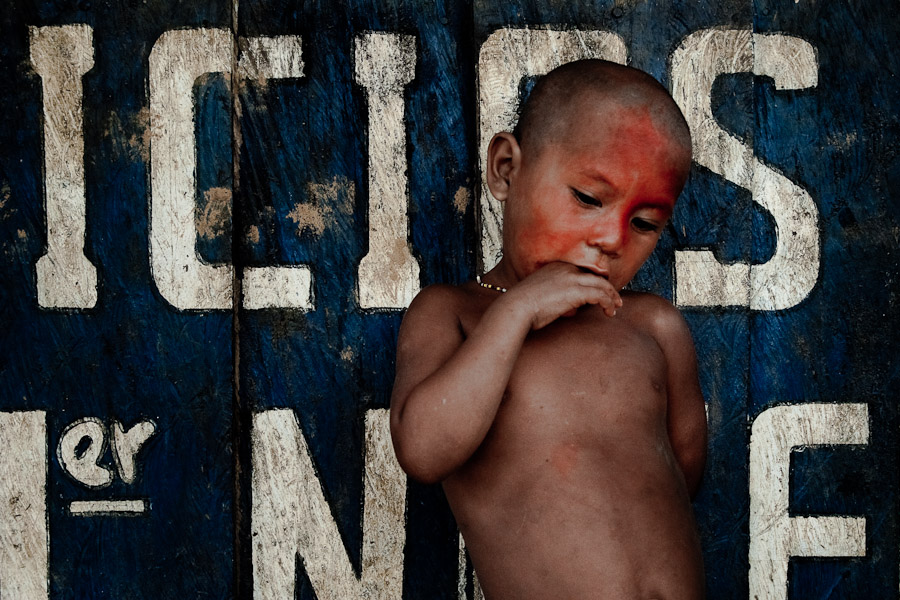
<box><xmin>0</xmin><ymin>0</ymin><xmax>900</xmax><ymax>600</ymax></box>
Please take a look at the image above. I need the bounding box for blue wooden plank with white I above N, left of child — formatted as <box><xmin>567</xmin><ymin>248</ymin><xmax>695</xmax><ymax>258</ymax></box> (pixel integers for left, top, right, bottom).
<box><xmin>235</xmin><ymin>0</ymin><xmax>475</xmax><ymax>599</ymax></box>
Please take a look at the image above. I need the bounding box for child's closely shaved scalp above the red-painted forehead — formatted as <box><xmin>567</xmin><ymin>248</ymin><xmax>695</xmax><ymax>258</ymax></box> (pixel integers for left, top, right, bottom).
<box><xmin>513</xmin><ymin>59</ymin><xmax>691</xmax><ymax>155</ymax></box>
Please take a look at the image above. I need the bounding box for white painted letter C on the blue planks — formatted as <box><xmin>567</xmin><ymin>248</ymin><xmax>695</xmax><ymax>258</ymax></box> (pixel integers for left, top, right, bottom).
<box><xmin>150</xmin><ymin>29</ymin><xmax>312</xmax><ymax>310</ymax></box>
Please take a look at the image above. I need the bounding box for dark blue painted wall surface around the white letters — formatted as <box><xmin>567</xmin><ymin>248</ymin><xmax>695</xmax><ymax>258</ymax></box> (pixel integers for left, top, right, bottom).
<box><xmin>0</xmin><ymin>0</ymin><xmax>900</xmax><ymax>600</ymax></box>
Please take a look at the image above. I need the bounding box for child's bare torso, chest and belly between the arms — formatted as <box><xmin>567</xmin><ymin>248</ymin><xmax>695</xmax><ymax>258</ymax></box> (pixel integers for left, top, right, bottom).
<box><xmin>444</xmin><ymin>316</ymin><xmax>704</xmax><ymax>600</ymax></box>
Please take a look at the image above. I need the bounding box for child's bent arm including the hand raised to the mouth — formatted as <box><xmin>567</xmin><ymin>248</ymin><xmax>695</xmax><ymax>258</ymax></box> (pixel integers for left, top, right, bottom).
<box><xmin>391</xmin><ymin>263</ymin><xmax>621</xmax><ymax>482</ymax></box>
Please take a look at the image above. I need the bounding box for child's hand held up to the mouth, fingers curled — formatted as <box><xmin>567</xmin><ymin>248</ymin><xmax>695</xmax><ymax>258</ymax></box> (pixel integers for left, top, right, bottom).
<box><xmin>506</xmin><ymin>262</ymin><xmax>622</xmax><ymax>329</ymax></box>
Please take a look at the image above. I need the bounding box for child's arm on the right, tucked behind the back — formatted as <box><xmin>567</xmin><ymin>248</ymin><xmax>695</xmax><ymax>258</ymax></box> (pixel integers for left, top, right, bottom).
<box><xmin>654</xmin><ymin>299</ymin><xmax>707</xmax><ymax>498</ymax></box>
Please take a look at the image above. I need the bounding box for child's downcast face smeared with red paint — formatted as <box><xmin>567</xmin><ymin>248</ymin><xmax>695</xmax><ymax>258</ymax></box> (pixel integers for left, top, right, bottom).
<box><xmin>503</xmin><ymin>103</ymin><xmax>690</xmax><ymax>289</ymax></box>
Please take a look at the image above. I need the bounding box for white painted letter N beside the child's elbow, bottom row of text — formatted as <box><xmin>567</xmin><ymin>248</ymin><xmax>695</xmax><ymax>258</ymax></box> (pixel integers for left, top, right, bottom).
<box><xmin>251</xmin><ymin>409</ymin><xmax>406</xmax><ymax>600</ymax></box>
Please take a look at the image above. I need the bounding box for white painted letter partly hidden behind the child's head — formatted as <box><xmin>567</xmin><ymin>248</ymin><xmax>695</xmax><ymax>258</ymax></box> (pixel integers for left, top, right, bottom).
<box><xmin>478</xmin><ymin>28</ymin><xmax>628</xmax><ymax>271</ymax></box>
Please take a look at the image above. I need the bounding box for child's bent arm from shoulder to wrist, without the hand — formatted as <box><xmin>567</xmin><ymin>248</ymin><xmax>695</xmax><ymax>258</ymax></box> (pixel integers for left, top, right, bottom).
<box><xmin>391</xmin><ymin>286</ymin><xmax>530</xmax><ymax>483</ymax></box>
